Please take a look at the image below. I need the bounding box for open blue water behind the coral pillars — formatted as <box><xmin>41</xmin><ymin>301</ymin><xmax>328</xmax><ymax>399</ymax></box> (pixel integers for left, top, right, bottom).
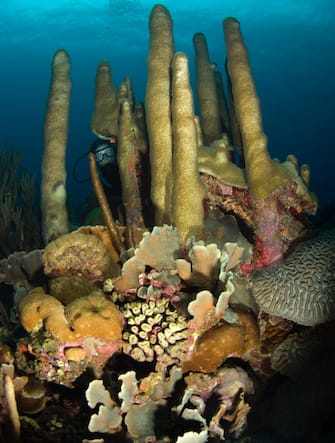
<box><xmin>0</xmin><ymin>0</ymin><xmax>335</xmax><ymax>215</ymax></box>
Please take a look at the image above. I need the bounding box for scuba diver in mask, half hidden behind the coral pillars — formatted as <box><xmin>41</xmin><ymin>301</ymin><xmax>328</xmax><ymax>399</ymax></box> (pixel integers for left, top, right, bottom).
<box><xmin>73</xmin><ymin>135</ymin><xmax>122</xmax><ymax>224</ymax></box>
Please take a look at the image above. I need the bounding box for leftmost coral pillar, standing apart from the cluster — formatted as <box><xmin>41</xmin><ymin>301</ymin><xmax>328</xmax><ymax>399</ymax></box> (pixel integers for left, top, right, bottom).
<box><xmin>41</xmin><ymin>50</ymin><xmax>71</xmax><ymax>243</ymax></box>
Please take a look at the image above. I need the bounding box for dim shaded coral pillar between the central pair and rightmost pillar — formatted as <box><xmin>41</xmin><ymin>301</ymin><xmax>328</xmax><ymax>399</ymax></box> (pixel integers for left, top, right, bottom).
<box><xmin>193</xmin><ymin>32</ymin><xmax>222</xmax><ymax>146</ymax></box>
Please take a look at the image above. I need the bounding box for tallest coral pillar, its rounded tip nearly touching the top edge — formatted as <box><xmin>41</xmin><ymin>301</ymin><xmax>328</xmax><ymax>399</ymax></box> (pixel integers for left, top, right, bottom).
<box><xmin>146</xmin><ymin>5</ymin><xmax>174</xmax><ymax>225</ymax></box>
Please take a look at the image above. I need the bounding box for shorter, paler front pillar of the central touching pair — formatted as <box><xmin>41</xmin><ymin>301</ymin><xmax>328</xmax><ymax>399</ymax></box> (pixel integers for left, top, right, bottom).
<box><xmin>172</xmin><ymin>52</ymin><xmax>205</xmax><ymax>244</ymax></box>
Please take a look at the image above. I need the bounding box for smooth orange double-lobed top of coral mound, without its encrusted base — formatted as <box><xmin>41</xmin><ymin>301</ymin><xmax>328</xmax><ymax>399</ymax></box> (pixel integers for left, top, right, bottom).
<box><xmin>19</xmin><ymin>288</ymin><xmax>123</xmax><ymax>343</ymax></box>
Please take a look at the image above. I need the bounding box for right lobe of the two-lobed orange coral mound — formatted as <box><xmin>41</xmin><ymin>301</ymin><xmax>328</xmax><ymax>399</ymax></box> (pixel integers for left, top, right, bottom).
<box><xmin>65</xmin><ymin>290</ymin><xmax>123</xmax><ymax>340</ymax></box>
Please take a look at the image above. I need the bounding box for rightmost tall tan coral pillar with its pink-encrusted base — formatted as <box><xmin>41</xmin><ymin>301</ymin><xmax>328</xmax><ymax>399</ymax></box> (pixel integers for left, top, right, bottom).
<box><xmin>223</xmin><ymin>18</ymin><xmax>317</xmax><ymax>268</ymax></box>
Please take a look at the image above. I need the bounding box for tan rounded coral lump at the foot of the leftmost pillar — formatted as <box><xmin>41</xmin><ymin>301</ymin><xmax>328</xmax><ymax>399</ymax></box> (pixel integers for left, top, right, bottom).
<box><xmin>43</xmin><ymin>231</ymin><xmax>113</xmax><ymax>282</ymax></box>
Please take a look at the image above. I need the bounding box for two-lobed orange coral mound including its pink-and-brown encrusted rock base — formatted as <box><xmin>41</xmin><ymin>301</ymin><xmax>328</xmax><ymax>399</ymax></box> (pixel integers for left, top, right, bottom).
<box><xmin>16</xmin><ymin>288</ymin><xmax>123</xmax><ymax>386</ymax></box>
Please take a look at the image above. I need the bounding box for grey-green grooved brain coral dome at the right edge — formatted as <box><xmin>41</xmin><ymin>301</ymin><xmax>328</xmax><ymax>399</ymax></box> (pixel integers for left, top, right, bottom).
<box><xmin>253</xmin><ymin>229</ymin><xmax>335</xmax><ymax>326</ymax></box>
